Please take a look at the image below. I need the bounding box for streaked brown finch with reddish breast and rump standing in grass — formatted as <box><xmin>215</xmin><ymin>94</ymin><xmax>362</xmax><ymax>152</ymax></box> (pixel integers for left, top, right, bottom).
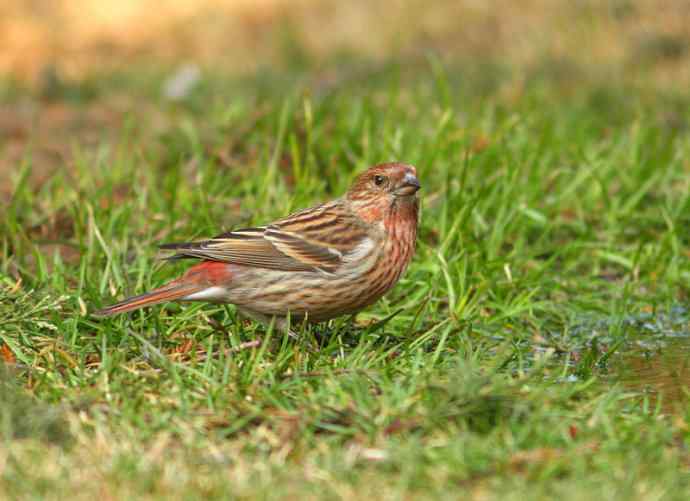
<box><xmin>96</xmin><ymin>163</ymin><xmax>420</xmax><ymax>328</ymax></box>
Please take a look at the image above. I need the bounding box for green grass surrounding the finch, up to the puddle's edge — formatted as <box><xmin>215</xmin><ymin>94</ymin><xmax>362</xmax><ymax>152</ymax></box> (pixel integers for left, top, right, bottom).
<box><xmin>0</xmin><ymin>59</ymin><xmax>690</xmax><ymax>499</ymax></box>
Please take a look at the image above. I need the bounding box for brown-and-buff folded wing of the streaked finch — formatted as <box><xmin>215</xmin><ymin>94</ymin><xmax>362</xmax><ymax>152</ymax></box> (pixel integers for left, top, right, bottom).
<box><xmin>161</xmin><ymin>199</ymin><xmax>367</xmax><ymax>272</ymax></box>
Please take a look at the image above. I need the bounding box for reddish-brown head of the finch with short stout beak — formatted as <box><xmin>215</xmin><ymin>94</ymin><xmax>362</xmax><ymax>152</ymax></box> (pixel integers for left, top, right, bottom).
<box><xmin>346</xmin><ymin>162</ymin><xmax>421</xmax><ymax>225</ymax></box>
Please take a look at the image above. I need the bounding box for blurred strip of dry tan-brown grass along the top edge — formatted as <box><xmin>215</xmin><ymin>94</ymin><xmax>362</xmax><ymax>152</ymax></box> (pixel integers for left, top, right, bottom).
<box><xmin>0</xmin><ymin>0</ymin><xmax>690</xmax><ymax>82</ymax></box>
